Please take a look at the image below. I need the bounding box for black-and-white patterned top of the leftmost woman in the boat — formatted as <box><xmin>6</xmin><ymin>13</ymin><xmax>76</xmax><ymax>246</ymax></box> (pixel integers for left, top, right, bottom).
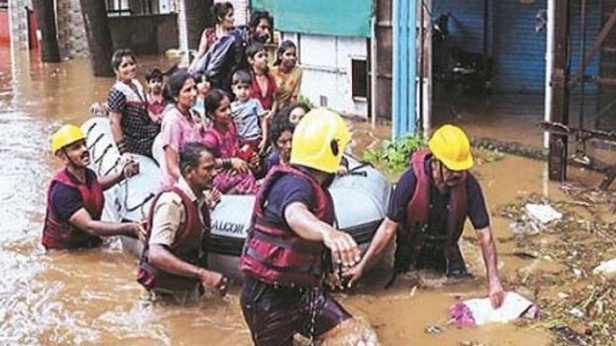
<box><xmin>107</xmin><ymin>80</ymin><xmax>160</xmax><ymax>157</ymax></box>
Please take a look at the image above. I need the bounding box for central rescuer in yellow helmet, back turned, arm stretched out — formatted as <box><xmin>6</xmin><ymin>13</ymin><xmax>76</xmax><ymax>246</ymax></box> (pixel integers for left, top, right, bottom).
<box><xmin>240</xmin><ymin>108</ymin><xmax>376</xmax><ymax>345</ymax></box>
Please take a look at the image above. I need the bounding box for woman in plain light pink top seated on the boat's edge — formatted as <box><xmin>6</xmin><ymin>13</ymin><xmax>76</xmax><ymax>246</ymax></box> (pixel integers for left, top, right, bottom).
<box><xmin>160</xmin><ymin>70</ymin><xmax>205</xmax><ymax>189</ymax></box>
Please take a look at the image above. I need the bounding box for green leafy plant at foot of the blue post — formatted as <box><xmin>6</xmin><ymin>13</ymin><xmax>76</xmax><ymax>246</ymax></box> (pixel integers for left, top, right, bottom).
<box><xmin>363</xmin><ymin>135</ymin><xmax>427</xmax><ymax>173</ymax></box>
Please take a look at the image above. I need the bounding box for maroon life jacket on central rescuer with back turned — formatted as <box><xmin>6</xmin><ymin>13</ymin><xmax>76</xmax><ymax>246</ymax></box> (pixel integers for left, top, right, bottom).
<box><xmin>240</xmin><ymin>166</ymin><xmax>334</xmax><ymax>287</ymax></box>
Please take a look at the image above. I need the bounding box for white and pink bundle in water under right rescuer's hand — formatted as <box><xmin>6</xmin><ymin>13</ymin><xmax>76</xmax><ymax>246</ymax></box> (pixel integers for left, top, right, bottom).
<box><xmin>449</xmin><ymin>292</ymin><xmax>539</xmax><ymax>327</ymax></box>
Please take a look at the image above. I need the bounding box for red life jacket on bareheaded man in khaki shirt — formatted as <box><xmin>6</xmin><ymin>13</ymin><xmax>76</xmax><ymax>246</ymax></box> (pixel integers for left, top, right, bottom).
<box><xmin>137</xmin><ymin>186</ymin><xmax>210</xmax><ymax>291</ymax></box>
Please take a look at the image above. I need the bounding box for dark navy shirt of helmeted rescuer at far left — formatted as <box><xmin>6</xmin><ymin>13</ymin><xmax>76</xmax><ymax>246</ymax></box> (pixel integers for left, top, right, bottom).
<box><xmin>51</xmin><ymin>169</ymin><xmax>96</xmax><ymax>222</ymax></box>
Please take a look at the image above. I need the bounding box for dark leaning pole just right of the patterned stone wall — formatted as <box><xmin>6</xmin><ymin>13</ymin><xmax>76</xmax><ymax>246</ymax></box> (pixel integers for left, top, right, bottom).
<box><xmin>80</xmin><ymin>0</ymin><xmax>114</xmax><ymax>77</ymax></box>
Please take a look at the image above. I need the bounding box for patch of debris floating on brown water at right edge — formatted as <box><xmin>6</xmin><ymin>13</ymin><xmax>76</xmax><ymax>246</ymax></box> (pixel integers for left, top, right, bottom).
<box><xmin>500</xmin><ymin>191</ymin><xmax>616</xmax><ymax>345</ymax></box>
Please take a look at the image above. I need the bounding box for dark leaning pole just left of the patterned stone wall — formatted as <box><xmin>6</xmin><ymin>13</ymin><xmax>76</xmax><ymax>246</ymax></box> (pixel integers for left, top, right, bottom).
<box><xmin>32</xmin><ymin>0</ymin><xmax>60</xmax><ymax>62</ymax></box>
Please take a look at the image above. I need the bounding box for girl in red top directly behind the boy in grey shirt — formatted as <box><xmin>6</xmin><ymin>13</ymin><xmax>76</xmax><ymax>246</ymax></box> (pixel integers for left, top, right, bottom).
<box><xmin>246</xmin><ymin>42</ymin><xmax>278</xmax><ymax>114</ymax></box>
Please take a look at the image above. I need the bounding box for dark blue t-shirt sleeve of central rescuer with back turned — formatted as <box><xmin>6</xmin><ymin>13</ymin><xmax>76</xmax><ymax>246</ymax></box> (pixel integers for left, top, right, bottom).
<box><xmin>263</xmin><ymin>174</ymin><xmax>316</xmax><ymax>227</ymax></box>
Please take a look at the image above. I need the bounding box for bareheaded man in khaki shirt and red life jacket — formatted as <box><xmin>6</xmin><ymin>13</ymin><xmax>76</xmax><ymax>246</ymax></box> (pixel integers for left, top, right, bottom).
<box><xmin>137</xmin><ymin>142</ymin><xmax>228</xmax><ymax>302</ymax></box>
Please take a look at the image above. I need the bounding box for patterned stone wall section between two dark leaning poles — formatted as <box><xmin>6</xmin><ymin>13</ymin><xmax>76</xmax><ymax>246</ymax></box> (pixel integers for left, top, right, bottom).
<box><xmin>56</xmin><ymin>0</ymin><xmax>90</xmax><ymax>59</ymax></box>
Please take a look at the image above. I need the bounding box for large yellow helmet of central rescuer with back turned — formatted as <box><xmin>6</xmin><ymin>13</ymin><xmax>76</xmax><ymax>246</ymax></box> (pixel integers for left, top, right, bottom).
<box><xmin>290</xmin><ymin>108</ymin><xmax>351</xmax><ymax>173</ymax></box>
